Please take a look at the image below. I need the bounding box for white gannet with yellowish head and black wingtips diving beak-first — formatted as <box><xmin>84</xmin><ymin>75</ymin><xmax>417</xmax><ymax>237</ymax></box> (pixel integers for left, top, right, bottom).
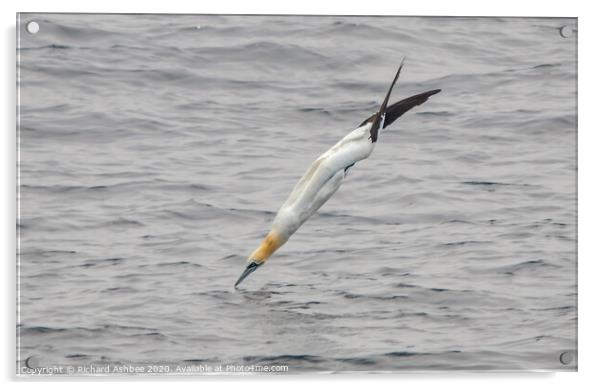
<box><xmin>234</xmin><ymin>60</ymin><xmax>441</xmax><ymax>287</ymax></box>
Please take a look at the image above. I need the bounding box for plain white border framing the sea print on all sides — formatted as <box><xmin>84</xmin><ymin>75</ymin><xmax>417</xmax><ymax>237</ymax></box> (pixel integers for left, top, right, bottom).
<box><xmin>0</xmin><ymin>0</ymin><xmax>602</xmax><ymax>390</ymax></box>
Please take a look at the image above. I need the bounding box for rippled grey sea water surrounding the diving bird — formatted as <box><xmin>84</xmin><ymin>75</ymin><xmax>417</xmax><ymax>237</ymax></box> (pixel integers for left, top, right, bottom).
<box><xmin>17</xmin><ymin>14</ymin><xmax>577</xmax><ymax>373</ymax></box>
